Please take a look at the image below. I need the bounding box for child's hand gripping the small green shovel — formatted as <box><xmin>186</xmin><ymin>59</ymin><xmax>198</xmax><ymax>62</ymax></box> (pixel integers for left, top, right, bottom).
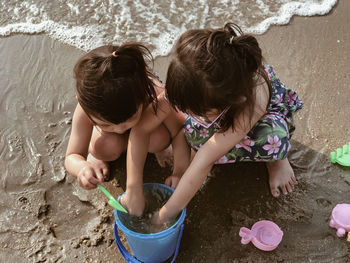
<box><xmin>77</xmin><ymin>162</ymin><xmax>106</xmax><ymax>190</ymax></box>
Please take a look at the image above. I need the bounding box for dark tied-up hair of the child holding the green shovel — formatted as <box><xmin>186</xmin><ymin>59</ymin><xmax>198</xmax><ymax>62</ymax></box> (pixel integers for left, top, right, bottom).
<box><xmin>74</xmin><ymin>43</ymin><xmax>157</xmax><ymax>124</ymax></box>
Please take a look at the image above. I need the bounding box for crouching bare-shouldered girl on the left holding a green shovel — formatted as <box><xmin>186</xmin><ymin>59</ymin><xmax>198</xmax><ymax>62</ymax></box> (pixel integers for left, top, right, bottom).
<box><xmin>65</xmin><ymin>43</ymin><xmax>188</xmax><ymax>196</ymax></box>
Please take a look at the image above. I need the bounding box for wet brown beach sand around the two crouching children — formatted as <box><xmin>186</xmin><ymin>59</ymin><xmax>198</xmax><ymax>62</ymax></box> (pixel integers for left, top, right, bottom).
<box><xmin>0</xmin><ymin>0</ymin><xmax>350</xmax><ymax>263</ymax></box>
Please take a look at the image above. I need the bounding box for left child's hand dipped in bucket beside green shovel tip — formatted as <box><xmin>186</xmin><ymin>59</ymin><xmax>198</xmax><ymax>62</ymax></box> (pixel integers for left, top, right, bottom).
<box><xmin>120</xmin><ymin>189</ymin><xmax>146</xmax><ymax>219</ymax></box>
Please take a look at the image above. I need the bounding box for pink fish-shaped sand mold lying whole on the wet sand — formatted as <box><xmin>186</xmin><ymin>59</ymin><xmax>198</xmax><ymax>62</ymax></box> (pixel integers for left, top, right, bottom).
<box><xmin>239</xmin><ymin>220</ymin><xmax>283</xmax><ymax>251</ymax></box>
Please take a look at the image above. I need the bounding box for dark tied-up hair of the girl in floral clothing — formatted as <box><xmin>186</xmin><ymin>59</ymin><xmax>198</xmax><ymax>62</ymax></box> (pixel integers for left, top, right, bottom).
<box><xmin>166</xmin><ymin>23</ymin><xmax>270</xmax><ymax>131</ymax></box>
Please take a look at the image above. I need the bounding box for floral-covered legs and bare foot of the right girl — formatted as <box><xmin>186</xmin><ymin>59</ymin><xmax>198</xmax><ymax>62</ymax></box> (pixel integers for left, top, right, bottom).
<box><xmin>185</xmin><ymin>114</ymin><xmax>296</xmax><ymax>197</ymax></box>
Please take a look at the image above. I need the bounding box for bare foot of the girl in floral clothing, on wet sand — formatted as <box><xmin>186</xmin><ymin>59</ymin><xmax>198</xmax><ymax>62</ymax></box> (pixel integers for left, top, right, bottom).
<box><xmin>266</xmin><ymin>158</ymin><xmax>297</xmax><ymax>197</ymax></box>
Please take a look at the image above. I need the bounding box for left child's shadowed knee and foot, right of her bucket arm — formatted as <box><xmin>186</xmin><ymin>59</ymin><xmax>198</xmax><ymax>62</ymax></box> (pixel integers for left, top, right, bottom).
<box><xmin>148</xmin><ymin>124</ymin><xmax>172</xmax><ymax>167</ymax></box>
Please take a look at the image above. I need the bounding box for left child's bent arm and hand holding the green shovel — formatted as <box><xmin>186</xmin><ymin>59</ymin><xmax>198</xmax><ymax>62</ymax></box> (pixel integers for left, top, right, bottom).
<box><xmin>64</xmin><ymin>104</ymin><xmax>104</xmax><ymax>189</ymax></box>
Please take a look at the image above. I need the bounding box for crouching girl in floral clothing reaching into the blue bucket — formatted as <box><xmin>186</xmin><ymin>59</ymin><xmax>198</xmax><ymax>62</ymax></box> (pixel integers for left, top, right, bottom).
<box><xmin>122</xmin><ymin>23</ymin><xmax>302</xmax><ymax>222</ymax></box>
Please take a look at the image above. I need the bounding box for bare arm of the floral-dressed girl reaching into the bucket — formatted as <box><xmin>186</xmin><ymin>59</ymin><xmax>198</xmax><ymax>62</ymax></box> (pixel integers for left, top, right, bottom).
<box><xmin>155</xmin><ymin>88</ymin><xmax>269</xmax><ymax>223</ymax></box>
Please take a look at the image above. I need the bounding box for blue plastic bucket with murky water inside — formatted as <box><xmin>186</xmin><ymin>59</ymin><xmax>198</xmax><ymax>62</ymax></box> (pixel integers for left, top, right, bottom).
<box><xmin>114</xmin><ymin>183</ymin><xmax>186</xmax><ymax>263</ymax></box>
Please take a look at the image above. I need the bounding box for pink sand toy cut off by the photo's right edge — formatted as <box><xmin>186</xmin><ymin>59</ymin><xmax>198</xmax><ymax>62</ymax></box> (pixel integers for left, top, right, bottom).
<box><xmin>329</xmin><ymin>204</ymin><xmax>350</xmax><ymax>237</ymax></box>
